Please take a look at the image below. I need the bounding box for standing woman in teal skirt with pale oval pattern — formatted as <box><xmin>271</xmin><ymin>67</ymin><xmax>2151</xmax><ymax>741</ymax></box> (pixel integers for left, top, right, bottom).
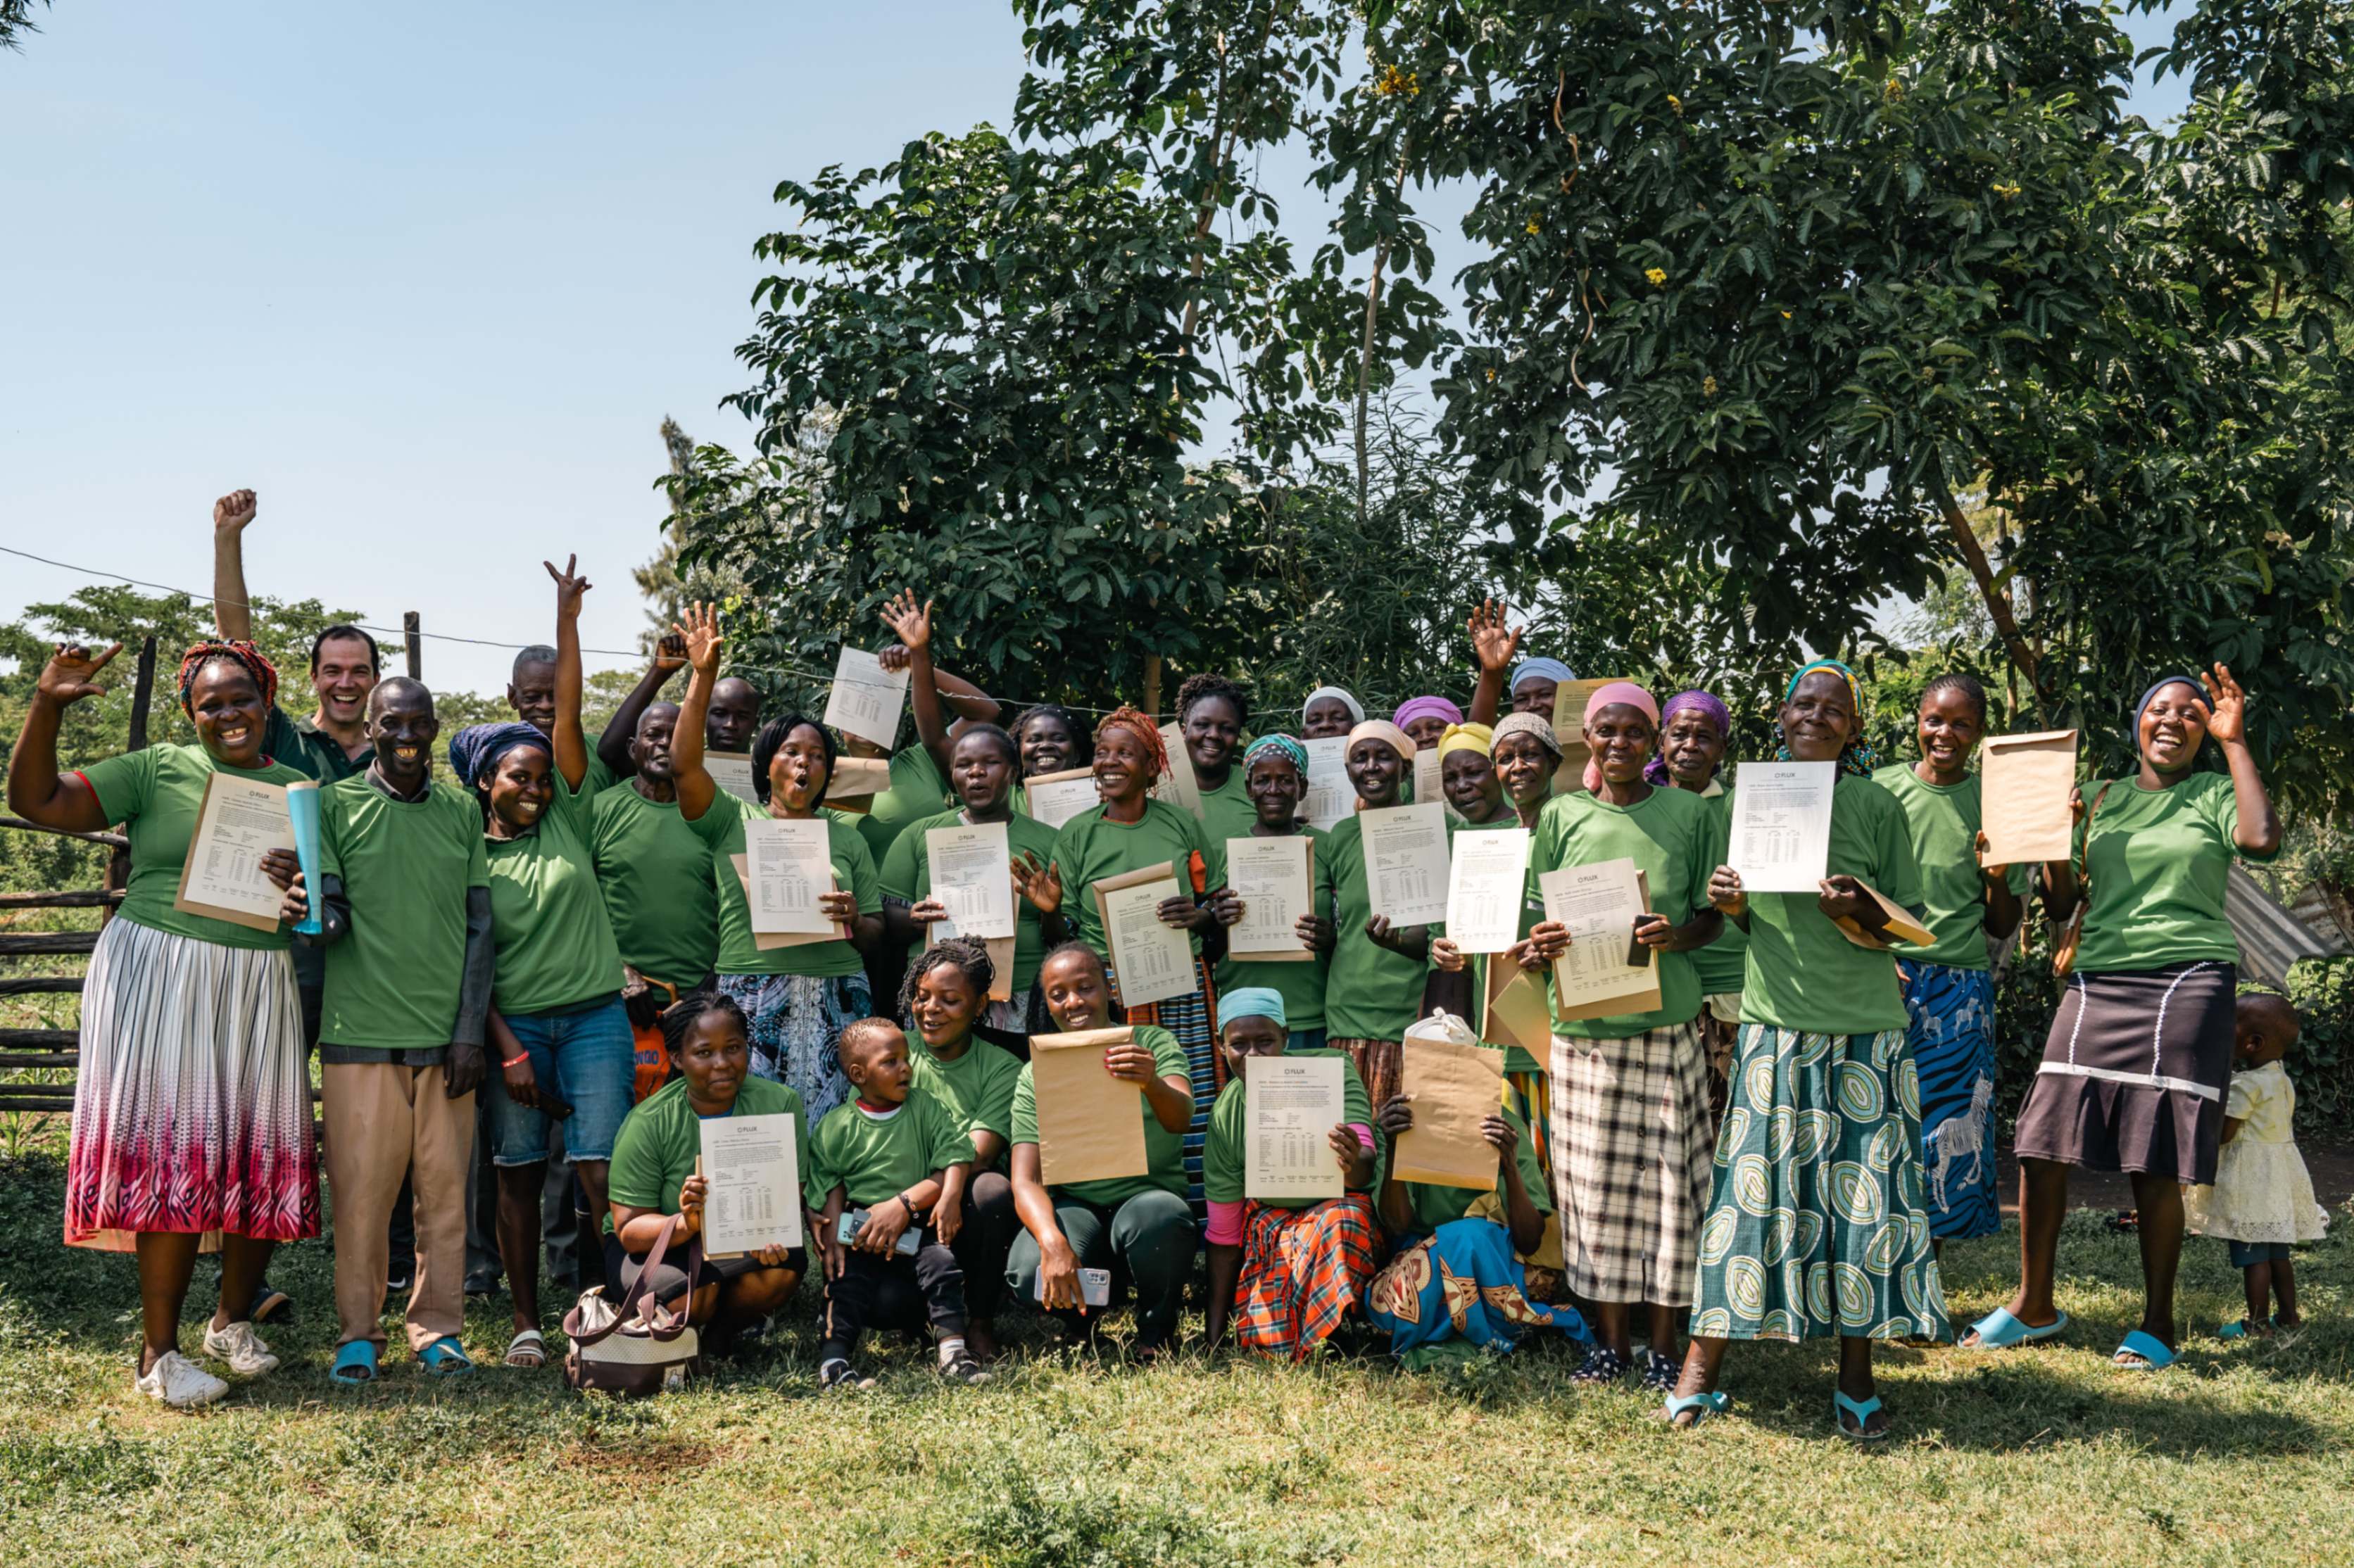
<box><xmin>1667</xmin><ymin>659</ymin><xmax>1951</xmax><ymax>1441</ymax></box>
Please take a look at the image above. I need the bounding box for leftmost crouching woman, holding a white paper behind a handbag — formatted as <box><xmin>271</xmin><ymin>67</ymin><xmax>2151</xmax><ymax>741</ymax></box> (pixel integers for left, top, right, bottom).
<box><xmin>605</xmin><ymin>991</ymin><xmax>810</xmax><ymax>1354</ymax></box>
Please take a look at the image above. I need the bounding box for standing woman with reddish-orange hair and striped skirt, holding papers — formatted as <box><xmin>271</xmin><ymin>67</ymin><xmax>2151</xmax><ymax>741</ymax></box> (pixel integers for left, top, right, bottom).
<box><xmin>1014</xmin><ymin>709</ymin><xmax>1226</xmax><ymax>1196</ymax></box>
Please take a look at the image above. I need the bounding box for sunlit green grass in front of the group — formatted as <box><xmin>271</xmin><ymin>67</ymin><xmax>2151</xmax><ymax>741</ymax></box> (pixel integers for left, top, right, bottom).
<box><xmin>0</xmin><ymin>1134</ymin><xmax>2354</xmax><ymax>1568</ymax></box>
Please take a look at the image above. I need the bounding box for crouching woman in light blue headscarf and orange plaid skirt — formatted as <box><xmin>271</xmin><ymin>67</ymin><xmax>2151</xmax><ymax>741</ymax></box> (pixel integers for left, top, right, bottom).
<box><xmin>1200</xmin><ymin>987</ymin><xmax>1382</xmax><ymax>1361</ymax></box>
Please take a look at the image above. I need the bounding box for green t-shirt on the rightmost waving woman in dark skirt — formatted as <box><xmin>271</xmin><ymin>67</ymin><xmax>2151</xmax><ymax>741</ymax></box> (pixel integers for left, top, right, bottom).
<box><xmin>2076</xmin><ymin>772</ymin><xmax>2272</xmax><ymax>975</ymax></box>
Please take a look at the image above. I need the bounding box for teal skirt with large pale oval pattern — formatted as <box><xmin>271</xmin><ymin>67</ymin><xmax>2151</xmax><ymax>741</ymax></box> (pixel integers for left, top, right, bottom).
<box><xmin>1692</xmin><ymin>1024</ymin><xmax>1954</xmax><ymax>1340</ymax></box>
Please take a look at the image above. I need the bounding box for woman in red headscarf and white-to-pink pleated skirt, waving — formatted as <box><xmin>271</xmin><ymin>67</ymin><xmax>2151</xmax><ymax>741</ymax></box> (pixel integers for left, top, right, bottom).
<box><xmin>7</xmin><ymin>643</ymin><xmax>317</xmax><ymax>1408</ymax></box>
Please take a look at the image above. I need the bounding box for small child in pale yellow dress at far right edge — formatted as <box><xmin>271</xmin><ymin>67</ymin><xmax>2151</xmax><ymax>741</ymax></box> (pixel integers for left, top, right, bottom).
<box><xmin>2182</xmin><ymin>994</ymin><xmax>2328</xmax><ymax>1340</ymax></box>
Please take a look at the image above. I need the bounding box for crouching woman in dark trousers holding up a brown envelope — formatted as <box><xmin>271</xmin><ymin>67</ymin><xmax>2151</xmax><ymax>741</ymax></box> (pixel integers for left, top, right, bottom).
<box><xmin>1005</xmin><ymin>942</ymin><xmax>1200</xmax><ymax>1358</ymax></box>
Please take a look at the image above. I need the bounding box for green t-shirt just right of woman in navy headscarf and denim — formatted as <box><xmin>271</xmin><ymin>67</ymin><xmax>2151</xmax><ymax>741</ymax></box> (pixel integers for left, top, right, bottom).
<box><xmin>588</xmin><ymin>784</ymin><xmax>720</xmax><ymax>991</ymax></box>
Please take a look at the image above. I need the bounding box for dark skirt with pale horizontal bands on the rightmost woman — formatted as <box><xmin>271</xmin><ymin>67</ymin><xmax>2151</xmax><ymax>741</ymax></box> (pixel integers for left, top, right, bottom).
<box><xmin>2010</xmin><ymin>963</ymin><xmax>2239</xmax><ymax>1182</ymax></box>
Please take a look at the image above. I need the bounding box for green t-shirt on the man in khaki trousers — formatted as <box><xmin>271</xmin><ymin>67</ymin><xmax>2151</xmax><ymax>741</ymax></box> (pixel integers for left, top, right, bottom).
<box><xmin>317</xmin><ymin>777</ymin><xmax>490</xmax><ymax>1050</ymax></box>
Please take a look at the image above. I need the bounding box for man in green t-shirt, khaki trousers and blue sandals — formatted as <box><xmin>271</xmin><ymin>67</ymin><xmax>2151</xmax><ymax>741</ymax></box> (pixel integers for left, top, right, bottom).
<box><xmin>274</xmin><ymin>678</ymin><xmax>492</xmax><ymax>1386</ymax></box>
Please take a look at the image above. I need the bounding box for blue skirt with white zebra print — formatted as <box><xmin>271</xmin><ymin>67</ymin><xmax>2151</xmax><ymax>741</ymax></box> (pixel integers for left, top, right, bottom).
<box><xmin>1897</xmin><ymin>959</ymin><xmax>2003</xmax><ymax>1241</ymax></box>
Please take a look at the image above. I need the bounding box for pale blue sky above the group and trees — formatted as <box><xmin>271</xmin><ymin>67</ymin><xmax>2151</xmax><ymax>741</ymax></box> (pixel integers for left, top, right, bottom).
<box><xmin>0</xmin><ymin>0</ymin><xmax>2182</xmax><ymax>690</ymax></box>
